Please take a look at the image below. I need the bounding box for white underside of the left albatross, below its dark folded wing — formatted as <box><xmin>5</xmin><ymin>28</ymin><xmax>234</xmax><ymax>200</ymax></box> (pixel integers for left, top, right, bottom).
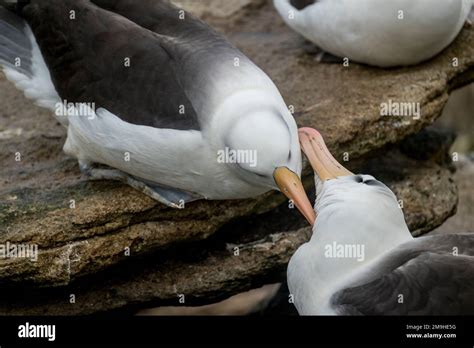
<box><xmin>64</xmin><ymin>109</ymin><xmax>274</xmax><ymax>199</ymax></box>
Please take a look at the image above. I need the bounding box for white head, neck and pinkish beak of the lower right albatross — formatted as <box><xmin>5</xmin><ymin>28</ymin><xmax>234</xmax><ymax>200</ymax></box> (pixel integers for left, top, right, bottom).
<box><xmin>288</xmin><ymin>128</ymin><xmax>412</xmax><ymax>314</ymax></box>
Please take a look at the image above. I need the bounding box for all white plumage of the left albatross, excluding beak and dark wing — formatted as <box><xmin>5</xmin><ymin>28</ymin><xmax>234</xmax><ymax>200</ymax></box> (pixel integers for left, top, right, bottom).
<box><xmin>4</xmin><ymin>27</ymin><xmax>301</xmax><ymax>199</ymax></box>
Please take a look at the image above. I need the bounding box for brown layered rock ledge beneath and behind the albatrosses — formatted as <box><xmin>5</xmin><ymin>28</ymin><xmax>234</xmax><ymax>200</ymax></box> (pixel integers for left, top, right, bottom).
<box><xmin>0</xmin><ymin>0</ymin><xmax>474</xmax><ymax>314</ymax></box>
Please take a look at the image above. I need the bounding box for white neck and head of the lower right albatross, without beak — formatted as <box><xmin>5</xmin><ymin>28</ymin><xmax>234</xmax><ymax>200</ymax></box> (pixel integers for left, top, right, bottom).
<box><xmin>288</xmin><ymin>175</ymin><xmax>412</xmax><ymax>314</ymax></box>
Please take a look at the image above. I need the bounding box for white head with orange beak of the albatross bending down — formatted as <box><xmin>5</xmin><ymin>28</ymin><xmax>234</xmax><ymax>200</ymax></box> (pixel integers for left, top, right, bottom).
<box><xmin>224</xmin><ymin>110</ymin><xmax>315</xmax><ymax>224</ymax></box>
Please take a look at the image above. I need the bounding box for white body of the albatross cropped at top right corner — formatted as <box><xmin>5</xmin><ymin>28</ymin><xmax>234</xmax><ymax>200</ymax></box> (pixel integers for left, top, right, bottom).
<box><xmin>274</xmin><ymin>0</ymin><xmax>473</xmax><ymax>67</ymax></box>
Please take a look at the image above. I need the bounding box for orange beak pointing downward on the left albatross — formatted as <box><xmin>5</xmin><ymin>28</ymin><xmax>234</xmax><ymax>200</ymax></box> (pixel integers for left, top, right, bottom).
<box><xmin>273</xmin><ymin>167</ymin><xmax>316</xmax><ymax>225</ymax></box>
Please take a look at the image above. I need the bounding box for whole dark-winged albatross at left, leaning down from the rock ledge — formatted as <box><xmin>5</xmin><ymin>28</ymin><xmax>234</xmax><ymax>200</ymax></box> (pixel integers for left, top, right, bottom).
<box><xmin>0</xmin><ymin>0</ymin><xmax>314</xmax><ymax>222</ymax></box>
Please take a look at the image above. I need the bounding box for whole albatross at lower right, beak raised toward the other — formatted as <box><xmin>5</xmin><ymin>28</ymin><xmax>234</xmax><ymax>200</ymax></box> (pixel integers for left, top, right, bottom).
<box><xmin>288</xmin><ymin>128</ymin><xmax>474</xmax><ymax>315</ymax></box>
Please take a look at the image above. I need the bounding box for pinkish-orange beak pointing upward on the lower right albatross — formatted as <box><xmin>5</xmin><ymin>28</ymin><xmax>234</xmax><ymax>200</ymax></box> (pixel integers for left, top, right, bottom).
<box><xmin>298</xmin><ymin>128</ymin><xmax>354</xmax><ymax>181</ymax></box>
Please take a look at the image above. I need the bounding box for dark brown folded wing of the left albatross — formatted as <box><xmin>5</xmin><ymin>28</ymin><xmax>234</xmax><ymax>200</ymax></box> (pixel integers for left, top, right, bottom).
<box><xmin>22</xmin><ymin>0</ymin><xmax>200</xmax><ymax>130</ymax></box>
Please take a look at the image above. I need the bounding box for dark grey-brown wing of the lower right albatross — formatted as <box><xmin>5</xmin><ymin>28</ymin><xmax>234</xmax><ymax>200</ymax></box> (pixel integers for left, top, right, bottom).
<box><xmin>331</xmin><ymin>234</ymin><xmax>474</xmax><ymax>315</ymax></box>
